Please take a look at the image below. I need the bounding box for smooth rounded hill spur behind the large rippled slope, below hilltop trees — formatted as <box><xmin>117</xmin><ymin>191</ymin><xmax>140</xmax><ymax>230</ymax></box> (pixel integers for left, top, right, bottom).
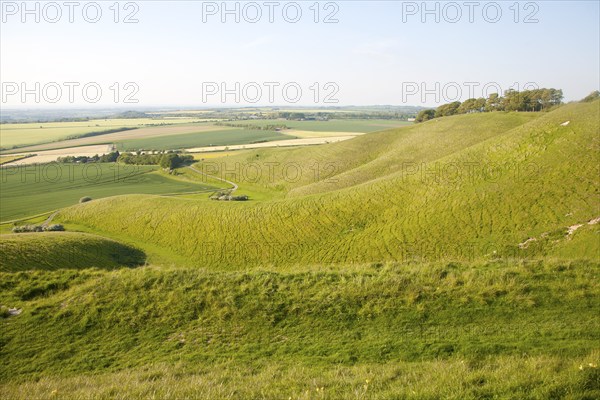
<box><xmin>199</xmin><ymin>113</ymin><xmax>540</xmax><ymax>196</ymax></box>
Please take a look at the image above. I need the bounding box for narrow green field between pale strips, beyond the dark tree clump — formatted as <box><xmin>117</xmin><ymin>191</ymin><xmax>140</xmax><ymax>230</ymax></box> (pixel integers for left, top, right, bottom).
<box><xmin>117</xmin><ymin>127</ymin><xmax>294</xmax><ymax>151</ymax></box>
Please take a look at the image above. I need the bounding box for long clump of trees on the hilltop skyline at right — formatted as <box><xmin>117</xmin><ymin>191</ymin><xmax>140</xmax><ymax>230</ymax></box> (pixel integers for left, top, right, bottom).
<box><xmin>415</xmin><ymin>88</ymin><xmax>564</xmax><ymax>122</ymax></box>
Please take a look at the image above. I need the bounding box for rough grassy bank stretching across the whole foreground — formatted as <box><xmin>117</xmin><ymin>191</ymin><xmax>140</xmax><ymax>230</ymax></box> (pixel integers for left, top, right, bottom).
<box><xmin>0</xmin><ymin>261</ymin><xmax>600</xmax><ymax>398</ymax></box>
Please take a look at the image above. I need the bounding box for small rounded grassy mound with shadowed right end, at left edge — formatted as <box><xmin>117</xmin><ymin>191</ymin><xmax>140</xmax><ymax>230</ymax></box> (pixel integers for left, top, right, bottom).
<box><xmin>0</xmin><ymin>232</ymin><xmax>145</xmax><ymax>272</ymax></box>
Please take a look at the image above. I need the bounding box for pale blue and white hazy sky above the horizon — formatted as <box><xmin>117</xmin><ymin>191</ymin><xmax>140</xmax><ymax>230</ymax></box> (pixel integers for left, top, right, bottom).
<box><xmin>0</xmin><ymin>0</ymin><xmax>600</xmax><ymax>109</ymax></box>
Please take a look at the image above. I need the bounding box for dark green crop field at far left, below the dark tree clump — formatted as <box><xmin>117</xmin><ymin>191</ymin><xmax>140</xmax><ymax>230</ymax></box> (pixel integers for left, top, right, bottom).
<box><xmin>0</xmin><ymin>163</ymin><xmax>220</xmax><ymax>221</ymax></box>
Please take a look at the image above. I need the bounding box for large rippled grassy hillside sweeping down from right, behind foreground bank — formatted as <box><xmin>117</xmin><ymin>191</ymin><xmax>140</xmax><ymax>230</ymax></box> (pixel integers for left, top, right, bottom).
<box><xmin>60</xmin><ymin>102</ymin><xmax>600</xmax><ymax>269</ymax></box>
